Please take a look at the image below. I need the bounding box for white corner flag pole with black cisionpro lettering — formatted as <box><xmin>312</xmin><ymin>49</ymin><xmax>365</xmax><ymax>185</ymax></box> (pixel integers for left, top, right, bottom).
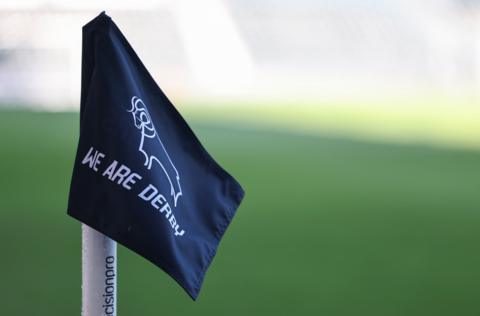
<box><xmin>82</xmin><ymin>224</ymin><xmax>117</xmax><ymax>316</ymax></box>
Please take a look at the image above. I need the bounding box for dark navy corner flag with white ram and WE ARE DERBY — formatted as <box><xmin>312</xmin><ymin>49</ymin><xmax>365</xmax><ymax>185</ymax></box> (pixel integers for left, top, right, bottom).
<box><xmin>67</xmin><ymin>12</ymin><xmax>244</xmax><ymax>299</ymax></box>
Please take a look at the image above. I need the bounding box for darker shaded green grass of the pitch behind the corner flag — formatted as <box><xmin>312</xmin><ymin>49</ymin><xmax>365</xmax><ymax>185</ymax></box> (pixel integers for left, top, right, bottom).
<box><xmin>0</xmin><ymin>111</ymin><xmax>480</xmax><ymax>316</ymax></box>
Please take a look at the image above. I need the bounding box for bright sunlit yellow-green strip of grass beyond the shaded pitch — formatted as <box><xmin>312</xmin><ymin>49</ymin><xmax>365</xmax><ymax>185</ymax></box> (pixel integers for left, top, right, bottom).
<box><xmin>185</xmin><ymin>96</ymin><xmax>480</xmax><ymax>150</ymax></box>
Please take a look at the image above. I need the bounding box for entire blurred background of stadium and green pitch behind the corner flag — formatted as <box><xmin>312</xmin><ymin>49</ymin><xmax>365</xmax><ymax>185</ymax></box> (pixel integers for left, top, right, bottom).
<box><xmin>0</xmin><ymin>0</ymin><xmax>480</xmax><ymax>316</ymax></box>
